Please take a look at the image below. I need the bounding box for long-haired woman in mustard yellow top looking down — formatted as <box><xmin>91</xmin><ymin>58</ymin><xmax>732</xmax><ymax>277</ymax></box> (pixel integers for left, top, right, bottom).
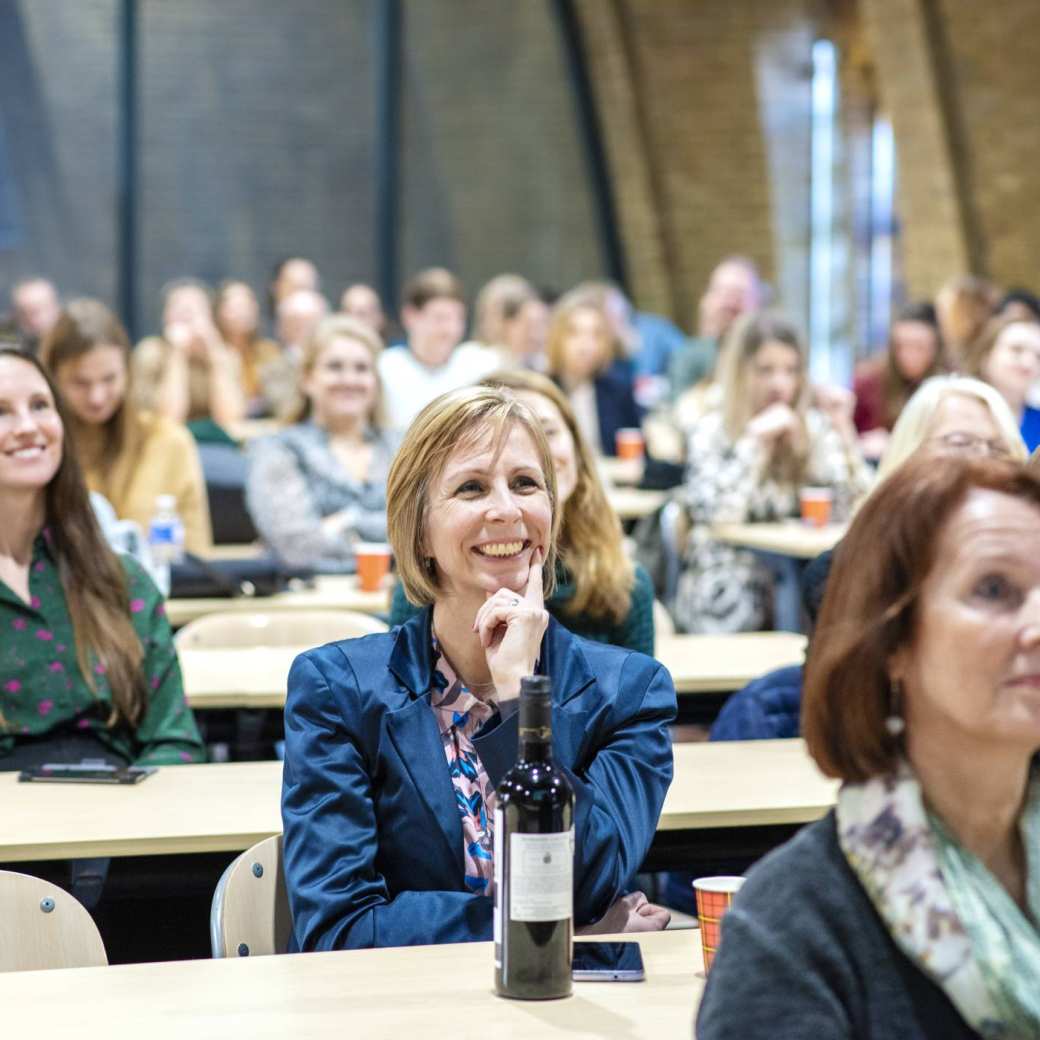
<box><xmin>41</xmin><ymin>300</ymin><xmax>212</xmax><ymax>552</ymax></box>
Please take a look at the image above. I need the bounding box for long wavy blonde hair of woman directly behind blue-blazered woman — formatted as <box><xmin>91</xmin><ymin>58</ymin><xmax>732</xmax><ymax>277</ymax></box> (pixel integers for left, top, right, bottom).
<box><xmin>482</xmin><ymin>368</ymin><xmax>635</xmax><ymax>624</ymax></box>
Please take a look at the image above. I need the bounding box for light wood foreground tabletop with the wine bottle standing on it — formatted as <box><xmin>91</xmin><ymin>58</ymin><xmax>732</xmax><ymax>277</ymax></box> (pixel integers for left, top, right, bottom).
<box><xmin>0</xmin><ymin>929</ymin><xmax>704</xmax><ymax>1040</ymax></box>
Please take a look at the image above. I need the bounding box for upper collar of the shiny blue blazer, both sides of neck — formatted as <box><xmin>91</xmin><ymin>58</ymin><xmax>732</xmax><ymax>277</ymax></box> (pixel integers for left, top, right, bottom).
<box><xmin>390</xmin><ymin>606</ymin><xmax>595</xmax><ymax>704</ymax></box>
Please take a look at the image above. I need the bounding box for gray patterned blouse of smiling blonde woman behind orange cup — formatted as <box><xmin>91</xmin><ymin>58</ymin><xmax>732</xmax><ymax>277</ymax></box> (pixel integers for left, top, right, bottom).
<box><xmin>245</xmin><ymin>422</ymin><xmax>399</xmax><ymax>573</ymax></box>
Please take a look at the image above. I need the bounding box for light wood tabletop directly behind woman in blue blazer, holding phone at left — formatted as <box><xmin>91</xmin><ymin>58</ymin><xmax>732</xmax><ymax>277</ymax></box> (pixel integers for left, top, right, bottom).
<box><xmin>0</xmin><ymin>740</ymin><xmax>837</xmax><ymax>863</ymax></box>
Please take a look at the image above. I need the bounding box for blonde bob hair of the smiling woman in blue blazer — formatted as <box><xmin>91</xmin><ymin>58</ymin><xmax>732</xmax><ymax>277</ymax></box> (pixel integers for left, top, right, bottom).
<box><xmin>387</xmin><ymin>386</ymin><xmax>560</xmax><ymax>606</ymax></box>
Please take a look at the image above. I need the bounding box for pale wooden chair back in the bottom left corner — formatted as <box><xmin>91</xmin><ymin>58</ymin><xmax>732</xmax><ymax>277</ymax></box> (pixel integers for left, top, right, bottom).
<box><xmin>0</xmin><ymin>870</ymin><xmax>108</xmax><ymax>971</ymax></box>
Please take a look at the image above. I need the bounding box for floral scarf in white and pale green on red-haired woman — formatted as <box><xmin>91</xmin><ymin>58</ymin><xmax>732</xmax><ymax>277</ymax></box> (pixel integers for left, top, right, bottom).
<box><xmin>836</xmin><ymin>761</ymin><xmax>1040</xmax><ymax>1040</ymax></box>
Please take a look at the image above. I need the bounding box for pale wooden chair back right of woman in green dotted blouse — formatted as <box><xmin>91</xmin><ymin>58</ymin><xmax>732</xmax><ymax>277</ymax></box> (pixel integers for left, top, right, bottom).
<box><xmin>174</xmin><ymin>610</ymin><xmax>387</xmax><ymax>650</ymax></box>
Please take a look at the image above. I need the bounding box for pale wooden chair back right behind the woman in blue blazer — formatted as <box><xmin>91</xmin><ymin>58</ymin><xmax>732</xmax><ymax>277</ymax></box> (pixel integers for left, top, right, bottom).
<box><xmin>209</xmin><ymin>834</ymin><xmax>292</xmax><ymax>957</ymax></box>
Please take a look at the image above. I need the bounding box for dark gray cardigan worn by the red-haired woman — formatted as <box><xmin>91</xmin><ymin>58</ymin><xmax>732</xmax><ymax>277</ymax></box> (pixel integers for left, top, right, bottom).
<box><xmin>697</xmin><ymin>812</ymin><xmax>979</xmax><ymax>1040</ymax></box>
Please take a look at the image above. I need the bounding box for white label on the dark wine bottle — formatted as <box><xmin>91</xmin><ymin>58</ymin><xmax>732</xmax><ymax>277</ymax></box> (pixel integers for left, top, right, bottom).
<box><xmin>507</xmin><ymin>828</ymin><xmax>574</xmax><ymax>920</ymax></box>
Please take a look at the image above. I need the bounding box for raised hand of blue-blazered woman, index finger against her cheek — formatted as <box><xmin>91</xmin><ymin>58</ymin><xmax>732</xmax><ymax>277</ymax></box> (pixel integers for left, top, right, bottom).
<box><xmin>473</xmin><ymin>546</ymin><xmax>549</xmax><ymax>701</ymax></box>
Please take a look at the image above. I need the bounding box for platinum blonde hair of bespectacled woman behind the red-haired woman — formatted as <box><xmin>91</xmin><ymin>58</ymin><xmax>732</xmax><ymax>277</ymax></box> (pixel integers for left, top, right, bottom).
<box><xmin>874</xmin><ymin>375</ymin><xmax>1029</xmax><ymax>490</ymax></box>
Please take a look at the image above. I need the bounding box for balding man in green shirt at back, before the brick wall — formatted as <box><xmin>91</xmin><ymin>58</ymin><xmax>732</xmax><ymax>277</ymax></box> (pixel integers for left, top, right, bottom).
<box><xmin>668</xmin><ymin>256</ymin><xmax>765</xmax><ymax>400</ymax></box>
